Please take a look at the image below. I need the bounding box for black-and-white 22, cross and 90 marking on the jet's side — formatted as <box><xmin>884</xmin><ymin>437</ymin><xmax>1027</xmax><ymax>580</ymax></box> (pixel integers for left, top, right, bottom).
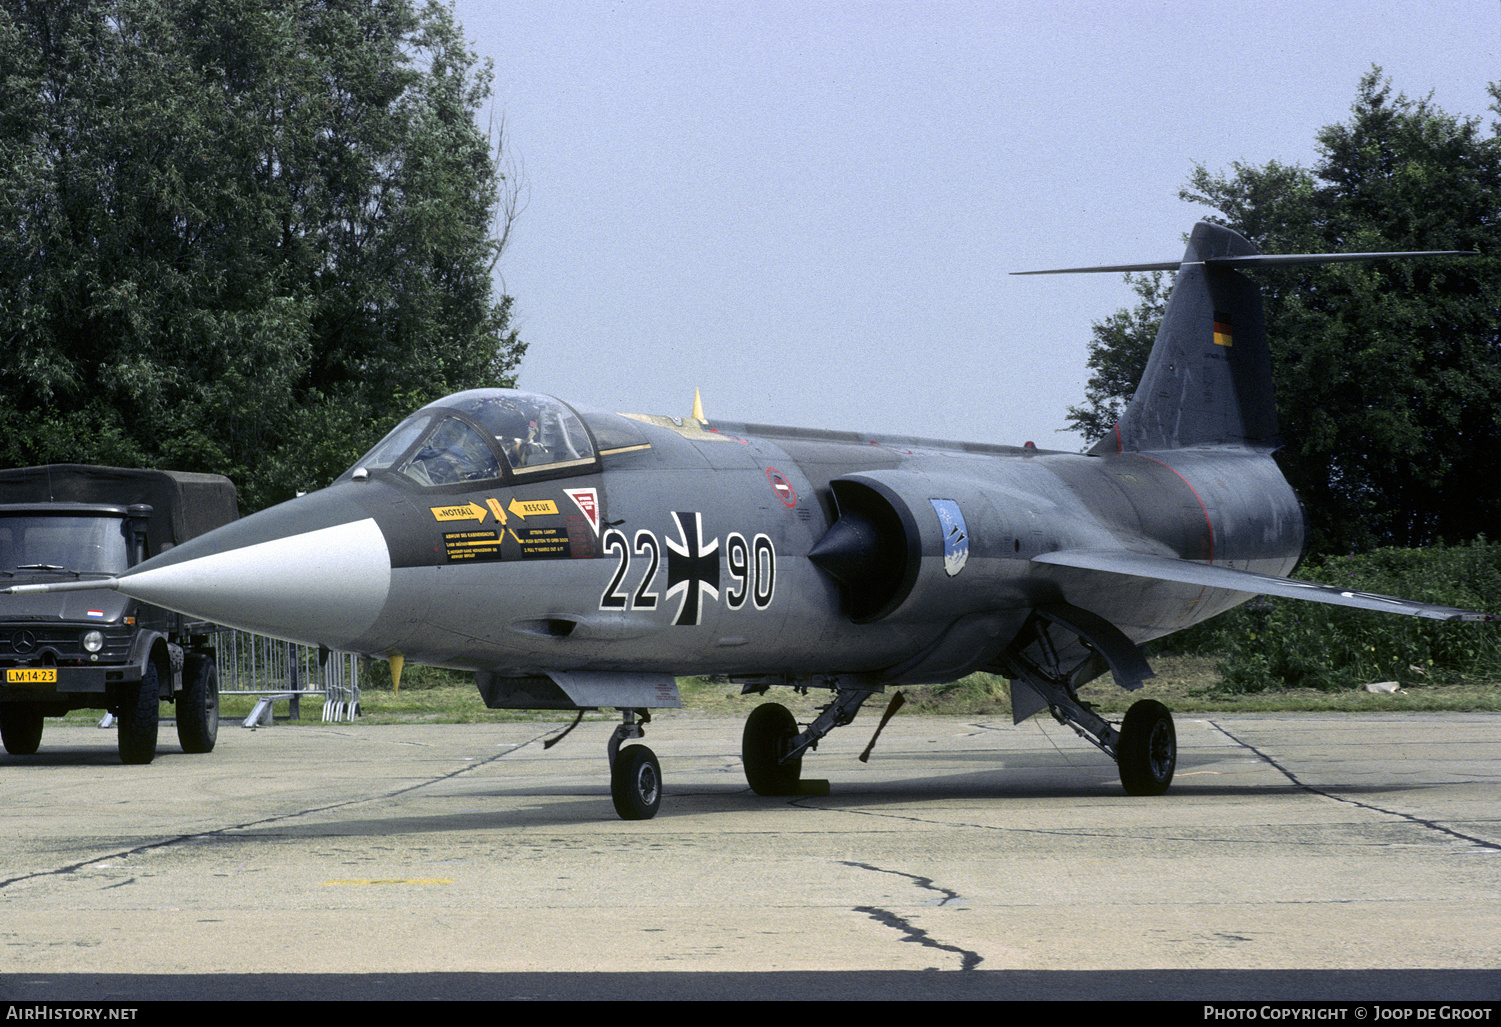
<box><xmin>599</xmin><ymin>512</ymin><xmax>776</xmax><ymax>625</ymax></box>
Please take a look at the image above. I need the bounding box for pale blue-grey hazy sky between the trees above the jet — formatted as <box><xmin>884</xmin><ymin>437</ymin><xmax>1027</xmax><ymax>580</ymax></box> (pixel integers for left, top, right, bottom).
<box><xmin>455</xmin><ymin>0</ymin><xmax>1501</xmax><ymax>449</ymax></box>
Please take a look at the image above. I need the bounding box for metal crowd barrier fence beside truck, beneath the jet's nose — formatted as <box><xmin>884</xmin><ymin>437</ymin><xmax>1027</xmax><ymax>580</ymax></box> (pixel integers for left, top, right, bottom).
<box><xmin>213</xmin><ymin>628</ymin><xmax>360</xmax><ymax>727</ymax></box>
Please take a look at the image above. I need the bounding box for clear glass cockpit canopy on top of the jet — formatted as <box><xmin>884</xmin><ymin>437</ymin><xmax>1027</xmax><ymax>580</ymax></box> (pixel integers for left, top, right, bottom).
<box><xmin>344</xmin><ymin>389</ymin><xmax>599</xmax><ymax>486</ymax></box>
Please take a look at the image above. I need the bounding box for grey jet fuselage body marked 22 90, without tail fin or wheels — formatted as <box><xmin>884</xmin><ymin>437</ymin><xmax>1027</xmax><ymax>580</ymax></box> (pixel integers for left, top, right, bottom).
<box><xmin>120</xmin><ymin>411</ymin><xmax>1303</xmax><ymax>682</ymax></box>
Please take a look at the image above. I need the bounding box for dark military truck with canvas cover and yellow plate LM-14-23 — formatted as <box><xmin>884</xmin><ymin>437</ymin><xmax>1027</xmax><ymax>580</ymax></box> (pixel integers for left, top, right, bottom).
<box><xmin>0</xmin><ymin>464</ymin><xmax>239</xmax><ymax>763</ymax></box>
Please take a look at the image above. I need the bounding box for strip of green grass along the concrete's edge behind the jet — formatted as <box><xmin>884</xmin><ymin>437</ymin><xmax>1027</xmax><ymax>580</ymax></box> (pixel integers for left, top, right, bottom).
<box><xmin>205</xmin><ymin>656</ymin><xmax>1501</xmax><ymax>724</ymax></box>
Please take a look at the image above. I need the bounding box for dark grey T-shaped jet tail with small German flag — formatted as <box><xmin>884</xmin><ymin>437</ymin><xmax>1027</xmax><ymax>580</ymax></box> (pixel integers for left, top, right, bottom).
<box><xmin>1022</xmin><ymin>221</ymin><xmax>1469</xmax><ymax>455</ymax></box>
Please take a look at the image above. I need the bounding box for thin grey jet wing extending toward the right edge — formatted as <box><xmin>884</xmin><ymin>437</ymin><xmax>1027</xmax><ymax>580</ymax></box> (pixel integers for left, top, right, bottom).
<box><xmin>1033</xmin><ymin>550</ymin><xmax>1496</xmax><ymax>622</ymax></box>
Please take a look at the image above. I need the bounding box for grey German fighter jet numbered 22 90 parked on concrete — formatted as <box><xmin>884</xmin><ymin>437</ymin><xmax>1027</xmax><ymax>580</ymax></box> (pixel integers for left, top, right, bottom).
<box><xmin>15</xmin><ymin>224</ymin><xmax>1490</xmax><ymax>818</ymax></box>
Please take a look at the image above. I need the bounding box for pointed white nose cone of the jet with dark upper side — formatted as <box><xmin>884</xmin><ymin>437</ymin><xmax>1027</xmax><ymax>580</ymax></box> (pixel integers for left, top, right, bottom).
<box><xmin>119</xmin><ymin>489</ymin><xmax>390</xmax><ymax>649</ymax></box>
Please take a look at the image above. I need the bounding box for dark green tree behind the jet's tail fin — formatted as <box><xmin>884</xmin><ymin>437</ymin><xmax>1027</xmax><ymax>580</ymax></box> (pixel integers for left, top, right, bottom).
<box><xmin>1070</xmin><ymin>69</ymin><xmax>1501</xmax><ymax>553</ymax></box>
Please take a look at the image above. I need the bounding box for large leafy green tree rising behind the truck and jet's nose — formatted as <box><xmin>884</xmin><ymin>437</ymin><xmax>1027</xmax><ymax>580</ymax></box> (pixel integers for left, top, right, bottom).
<box><xmin>0</xmin><ymin>0</ymin><xmax>524</xmax><ymax>509</ymax></box>
